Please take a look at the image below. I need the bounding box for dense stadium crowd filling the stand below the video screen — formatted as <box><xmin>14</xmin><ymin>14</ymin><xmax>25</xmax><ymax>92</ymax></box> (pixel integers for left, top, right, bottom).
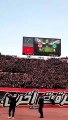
<box><xmin>0</xmin><ymin>54</ymin><xmax>68</xmax><ymax>89</ymax></box>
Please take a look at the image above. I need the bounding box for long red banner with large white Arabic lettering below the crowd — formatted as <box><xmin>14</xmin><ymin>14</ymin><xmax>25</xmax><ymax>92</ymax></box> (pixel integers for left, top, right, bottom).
<box><xmin>0</xmin><ymin>88</ymin><xmax>68</xmax><ymax>108</ymax></box>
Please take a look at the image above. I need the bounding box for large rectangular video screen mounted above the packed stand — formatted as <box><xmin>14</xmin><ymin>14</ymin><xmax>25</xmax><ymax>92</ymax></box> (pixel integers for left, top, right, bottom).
<box><xmin>22</xmin><ymin>37</ymin><xmax>61</xmax><ymax>56</ymax></box>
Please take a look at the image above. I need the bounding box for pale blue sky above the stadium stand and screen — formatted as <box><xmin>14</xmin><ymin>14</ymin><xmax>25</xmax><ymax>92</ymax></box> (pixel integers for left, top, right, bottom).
<box><xmin>0</xmin><ymin>0</ymin><xmax>68</xmax><ymax>57</ymax></box>
